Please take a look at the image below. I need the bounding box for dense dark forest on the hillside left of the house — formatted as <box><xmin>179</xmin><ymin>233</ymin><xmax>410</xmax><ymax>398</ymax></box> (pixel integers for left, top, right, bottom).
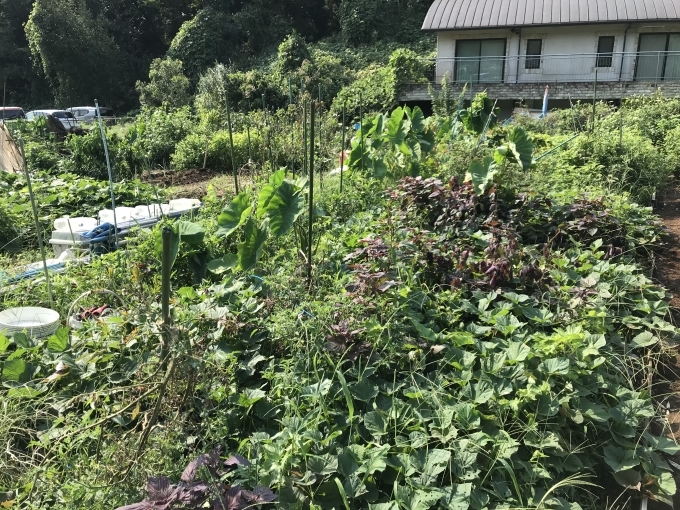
<box><xmin>0</xmin><ymin>0</ymin><xmax>431</xmax><ymax>112</ymax></box>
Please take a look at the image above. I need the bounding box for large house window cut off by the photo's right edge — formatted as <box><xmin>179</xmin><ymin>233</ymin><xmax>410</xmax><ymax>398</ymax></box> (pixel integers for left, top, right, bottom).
<box><xmin>635</xmin><ymin>33</ymin><xmax>680</xmax><ymax>81</ymax></box>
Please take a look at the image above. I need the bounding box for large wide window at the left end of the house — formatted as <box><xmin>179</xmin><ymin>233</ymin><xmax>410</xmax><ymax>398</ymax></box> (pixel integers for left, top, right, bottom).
<box><xmin>455</xmin><ymin>39</ymin><xmax>505</xmax><ymax>83</ymax></box>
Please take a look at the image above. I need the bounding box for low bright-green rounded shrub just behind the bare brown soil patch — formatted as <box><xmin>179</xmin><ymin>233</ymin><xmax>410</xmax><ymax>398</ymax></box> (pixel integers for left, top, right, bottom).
<box><xmin>172</xmin><ymin>130</ymin><xmax>262</xmax><ymax>171</ymax></box>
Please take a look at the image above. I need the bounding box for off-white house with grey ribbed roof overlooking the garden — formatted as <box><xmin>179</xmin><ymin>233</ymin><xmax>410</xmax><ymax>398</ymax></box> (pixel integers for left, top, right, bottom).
<box><xmin>401</xmin><ymin>0</ymin><xmax>680</xmax><ymax>111</ymax></box>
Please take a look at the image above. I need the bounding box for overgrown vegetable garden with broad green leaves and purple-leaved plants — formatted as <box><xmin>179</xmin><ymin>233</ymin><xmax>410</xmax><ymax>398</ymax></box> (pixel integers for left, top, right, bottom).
<box><xmin>0</xmin><ymin>86</ymin><xmax>680</xmax><ymax>510</ymax></box>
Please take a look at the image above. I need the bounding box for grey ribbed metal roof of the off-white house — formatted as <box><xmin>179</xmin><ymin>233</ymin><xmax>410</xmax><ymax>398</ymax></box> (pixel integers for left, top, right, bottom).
<box><xmin>423</xmin><ymin>0</ymin><xmax>680</xmax><ymax>30</ymax></box>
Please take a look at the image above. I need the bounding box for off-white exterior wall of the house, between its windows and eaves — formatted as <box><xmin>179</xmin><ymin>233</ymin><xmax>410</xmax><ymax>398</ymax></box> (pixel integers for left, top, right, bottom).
<box><xmin>436</xmin><ymin>23</ymin><xmax>680</xmax><ymax>83</ymax></box>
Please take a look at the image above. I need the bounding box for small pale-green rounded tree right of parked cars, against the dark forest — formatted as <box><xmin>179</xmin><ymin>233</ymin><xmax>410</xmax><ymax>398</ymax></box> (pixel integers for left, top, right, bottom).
<box><xmin>136</xmin><ymin>58</ymin><xmax>191</xmax><ymax>108</ymax></box>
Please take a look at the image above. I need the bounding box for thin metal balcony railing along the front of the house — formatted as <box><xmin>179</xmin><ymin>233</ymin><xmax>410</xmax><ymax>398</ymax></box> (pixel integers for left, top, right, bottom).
<box><xmin>430</xmin><ymin>51</ymin><xmax>680</xmax><ymax>83</ymax></box>
